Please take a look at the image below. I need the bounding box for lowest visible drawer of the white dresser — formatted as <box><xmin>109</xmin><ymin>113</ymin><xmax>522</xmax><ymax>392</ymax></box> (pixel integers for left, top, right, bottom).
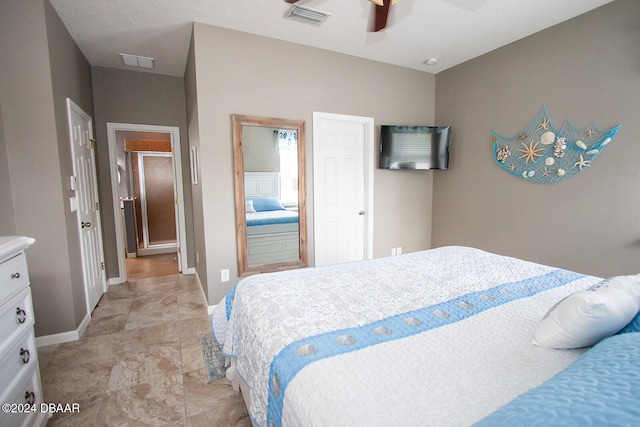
<box><xmin>0</xmin><ymin>365</ymin><xmax>45</xmax><ymax>427</ymax></box>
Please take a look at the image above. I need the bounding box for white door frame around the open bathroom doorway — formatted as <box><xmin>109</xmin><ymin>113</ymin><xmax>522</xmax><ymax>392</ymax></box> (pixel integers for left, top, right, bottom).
<box><xmin>107</xmin><ymin>122</ymin><xmax>187</xmax><ymax>284</ymax></box>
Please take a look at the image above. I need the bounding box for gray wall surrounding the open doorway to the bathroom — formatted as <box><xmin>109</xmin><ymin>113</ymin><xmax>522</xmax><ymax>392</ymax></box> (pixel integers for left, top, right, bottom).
<box><xmin>92</xmin><ymin>67</ymin><xmax>195</xmax><ymax>278</ymax></box>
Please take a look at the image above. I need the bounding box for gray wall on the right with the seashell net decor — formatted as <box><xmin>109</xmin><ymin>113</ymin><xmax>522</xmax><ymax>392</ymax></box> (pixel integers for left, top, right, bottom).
<box><xmin>432</xmin><ymin>0</ymin><xmax>640</xmax><ymax>276</ymax></box>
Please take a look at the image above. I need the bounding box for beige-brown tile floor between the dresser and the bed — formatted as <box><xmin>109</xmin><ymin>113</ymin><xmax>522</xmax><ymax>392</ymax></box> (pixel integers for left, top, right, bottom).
<box><xmin>38</xmin><ymin>274</ymin><xmax>251</xmax><ymax>427</ymax></box>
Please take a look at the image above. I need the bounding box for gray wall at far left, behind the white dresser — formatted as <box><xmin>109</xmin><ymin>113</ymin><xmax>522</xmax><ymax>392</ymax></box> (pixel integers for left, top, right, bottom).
<box><xmin>0</xmin><ymin>0</ymin><xmax>93</xmax><ymax>336</ymax></box>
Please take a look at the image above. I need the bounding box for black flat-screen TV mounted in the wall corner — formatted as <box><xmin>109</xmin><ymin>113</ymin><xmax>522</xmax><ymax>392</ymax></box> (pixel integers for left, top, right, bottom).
<box><xmin>378</xmin><ymin>125</ymin><xmax>451</xmax><ymax>169</ymax></box>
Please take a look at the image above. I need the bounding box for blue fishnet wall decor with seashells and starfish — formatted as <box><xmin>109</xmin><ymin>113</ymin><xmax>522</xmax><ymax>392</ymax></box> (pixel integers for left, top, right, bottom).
<box><xmin>491</xmin><ymin>106</ymin><xmax>621</xmax><ymax>184</ymax></box>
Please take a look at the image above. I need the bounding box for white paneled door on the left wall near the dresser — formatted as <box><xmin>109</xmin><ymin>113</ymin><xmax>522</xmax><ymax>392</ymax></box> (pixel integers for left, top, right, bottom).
<box><xmin>67</xmin><ymin>98</ymin><xmax>107</xmax><ymax>313</ymax></box>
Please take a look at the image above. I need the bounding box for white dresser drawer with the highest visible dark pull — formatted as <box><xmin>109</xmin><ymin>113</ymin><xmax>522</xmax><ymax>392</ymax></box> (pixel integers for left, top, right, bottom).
<box><xmin>0</xmin><ymin>287</ymin><xmax>34</xmax><ymax>354</ymax></box>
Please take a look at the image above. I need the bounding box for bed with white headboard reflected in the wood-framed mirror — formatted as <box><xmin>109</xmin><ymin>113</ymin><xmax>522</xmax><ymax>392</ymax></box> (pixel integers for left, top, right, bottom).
<box><xmin>244</xmin><ymin>172</ymin><xmax>300</xmax><ymax>265</ymax></box>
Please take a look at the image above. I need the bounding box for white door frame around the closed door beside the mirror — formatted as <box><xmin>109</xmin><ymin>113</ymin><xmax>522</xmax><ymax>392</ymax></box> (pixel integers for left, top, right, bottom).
<box><xmin>313</xmin><ymin>111</ymin><xmax>375</xmax><ymax>264</ymax></box>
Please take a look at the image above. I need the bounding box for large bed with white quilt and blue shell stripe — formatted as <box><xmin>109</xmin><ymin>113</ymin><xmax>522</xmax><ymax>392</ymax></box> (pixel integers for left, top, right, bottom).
<box><xmin>212</xmin><ymin>246</ymin><xmax>640</xmax><ymax>426</ymax></box>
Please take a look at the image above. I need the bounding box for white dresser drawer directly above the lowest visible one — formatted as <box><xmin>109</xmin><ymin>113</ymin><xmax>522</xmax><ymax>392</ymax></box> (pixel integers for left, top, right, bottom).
<box><xmin>0</xmin><ymin>329</ymin><xmax>38</xmax><ymax>394</ymax></box>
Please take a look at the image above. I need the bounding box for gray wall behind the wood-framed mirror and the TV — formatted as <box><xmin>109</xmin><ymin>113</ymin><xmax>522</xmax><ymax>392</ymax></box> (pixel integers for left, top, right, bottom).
<box><xmin>185</xmin><ymin>23</ymin><xmax>435</xmax><ymax>304</ymax></box>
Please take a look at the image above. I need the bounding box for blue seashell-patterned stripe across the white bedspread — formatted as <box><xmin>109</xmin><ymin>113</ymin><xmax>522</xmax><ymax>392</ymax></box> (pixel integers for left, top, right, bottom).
<box><xmin>266</xmin><ymin>270</ymin><xmax>585</xmax><ymax>426</ymax></box>
